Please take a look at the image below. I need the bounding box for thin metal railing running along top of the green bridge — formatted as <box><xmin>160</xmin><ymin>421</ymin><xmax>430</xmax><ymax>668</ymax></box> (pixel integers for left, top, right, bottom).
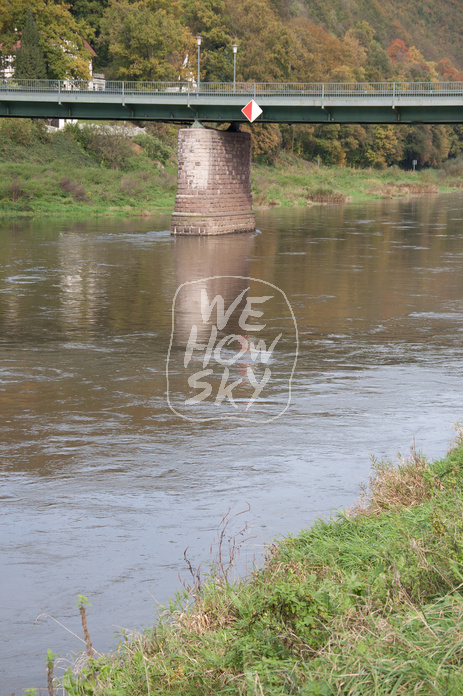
<box><xmin>0</xmin><ymin>78</ymin><xmax>463</xmax><ymax>99</ymax></box>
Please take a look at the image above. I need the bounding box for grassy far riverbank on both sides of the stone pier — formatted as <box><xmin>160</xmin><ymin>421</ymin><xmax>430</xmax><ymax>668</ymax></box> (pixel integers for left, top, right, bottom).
<box><xmin>0</xmin><ymin>119</ymin><xmax>463</xmax><ymax>220</ymax></box>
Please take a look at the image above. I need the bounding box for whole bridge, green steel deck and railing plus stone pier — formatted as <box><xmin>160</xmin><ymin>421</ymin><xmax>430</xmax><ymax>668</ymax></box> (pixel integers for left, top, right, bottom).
<box><xmin>4</xmin><ymin>78</ymin><xmax>463</xmax><ymax>235</ymax></box>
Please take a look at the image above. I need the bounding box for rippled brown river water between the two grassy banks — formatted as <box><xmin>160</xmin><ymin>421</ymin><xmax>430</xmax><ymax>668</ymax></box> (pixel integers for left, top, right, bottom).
<box><xmin>0</xmin><ymin>194</ymin><xmax>463</xmax><ymax>696</ymax></box>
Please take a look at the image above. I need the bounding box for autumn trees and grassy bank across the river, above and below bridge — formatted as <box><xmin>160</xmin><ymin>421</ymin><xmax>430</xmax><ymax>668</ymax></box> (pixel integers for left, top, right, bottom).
<box><xmin>4</xmin><ymin>0</ymin><xmax>463</xmax><ymax>219</ymax></box>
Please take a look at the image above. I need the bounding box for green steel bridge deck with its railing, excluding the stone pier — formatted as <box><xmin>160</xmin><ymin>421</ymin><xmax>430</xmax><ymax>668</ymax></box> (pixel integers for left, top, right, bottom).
<box><xmin>0</xmin><ymin>78</ymin><xmax>463</xmax><ymax>123</ymax></box>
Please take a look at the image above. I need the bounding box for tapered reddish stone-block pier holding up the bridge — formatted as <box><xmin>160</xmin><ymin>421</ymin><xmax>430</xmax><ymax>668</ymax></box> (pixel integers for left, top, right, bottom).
<box><xmin>170</xmin><ymin>126</ymin><xmax>255</xmax><ymax>235</ymax></box>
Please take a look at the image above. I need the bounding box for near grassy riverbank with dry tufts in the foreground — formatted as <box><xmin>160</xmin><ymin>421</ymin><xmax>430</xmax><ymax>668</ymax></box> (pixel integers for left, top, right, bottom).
<box><xmin>59</xmin><ymin>429</ymin><xmax>463</xmax><ymax>696</ymax></box>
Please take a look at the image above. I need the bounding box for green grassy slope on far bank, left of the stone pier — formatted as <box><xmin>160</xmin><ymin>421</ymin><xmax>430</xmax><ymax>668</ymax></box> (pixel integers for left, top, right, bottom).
<box><xmin>0</xmin><ymin>120</ymin><xmax>177</xmax><ymax>219</ymax></box>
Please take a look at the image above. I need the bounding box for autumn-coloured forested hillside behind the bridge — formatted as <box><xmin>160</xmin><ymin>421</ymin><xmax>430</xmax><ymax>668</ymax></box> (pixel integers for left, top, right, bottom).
<box><xmin>0</xmin><ymin>0</ymin><xmax>463</xmax><ymax>168</ymax></box>
